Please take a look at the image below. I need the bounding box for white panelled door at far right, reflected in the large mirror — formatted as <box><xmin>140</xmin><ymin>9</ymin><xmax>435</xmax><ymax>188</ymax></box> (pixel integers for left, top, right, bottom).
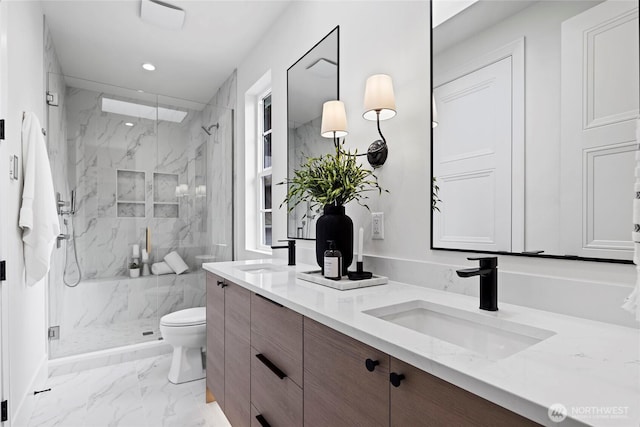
<box><xmin>561</xmin><ymin>0</ymin><xmax>640</xmax><ymax>260</ymax></box>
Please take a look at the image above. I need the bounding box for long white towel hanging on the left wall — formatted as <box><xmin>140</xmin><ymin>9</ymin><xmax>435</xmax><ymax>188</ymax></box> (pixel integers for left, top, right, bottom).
<box><xmin>18</xmin><ymin>113</ymin><xmax>60</xmax><ymax>285</ymax></box>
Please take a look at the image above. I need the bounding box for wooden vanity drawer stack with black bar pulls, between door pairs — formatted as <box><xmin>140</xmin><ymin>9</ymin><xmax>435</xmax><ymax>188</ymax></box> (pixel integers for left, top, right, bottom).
<box><xmin>251</xmin><ymin>294</ymin><xmax>303</xmax><ymax>427</ymax></box>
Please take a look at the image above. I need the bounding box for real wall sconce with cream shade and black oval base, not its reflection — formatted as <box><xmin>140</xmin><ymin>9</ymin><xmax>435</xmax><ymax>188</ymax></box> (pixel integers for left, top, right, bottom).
<box><xmin>362</xmin><ymin>74</ymin><xmax>396</xmax><ymax>168</ymax></box>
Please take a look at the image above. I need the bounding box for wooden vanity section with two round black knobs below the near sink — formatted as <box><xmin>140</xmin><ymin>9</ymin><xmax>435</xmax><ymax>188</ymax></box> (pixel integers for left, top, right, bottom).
<box><xmin>304</xmin><ymin>318</ymin><xmax>538</xmax><ymax>427</ymax></box>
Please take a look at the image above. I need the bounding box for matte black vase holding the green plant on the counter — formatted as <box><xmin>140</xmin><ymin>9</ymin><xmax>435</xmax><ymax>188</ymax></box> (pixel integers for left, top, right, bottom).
<box><xmin>316</xmin><ymin>205</ymin><xmax>353</xmax><ymax>276</ymax></box>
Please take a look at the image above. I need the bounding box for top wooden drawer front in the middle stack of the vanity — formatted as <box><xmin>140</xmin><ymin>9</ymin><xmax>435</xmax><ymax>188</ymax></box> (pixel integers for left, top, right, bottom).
<box><xmin>251</xmin><ymin>294</ymin><xmax>302</xmax><ymax>387</ymax></box>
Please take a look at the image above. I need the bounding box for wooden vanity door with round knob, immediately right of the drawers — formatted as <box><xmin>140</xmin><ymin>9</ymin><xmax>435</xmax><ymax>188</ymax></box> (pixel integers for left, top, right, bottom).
<box><xmin>304</xmin><ymin>318</ymin><xmax>390</xmax><ymax>427</ymax></box>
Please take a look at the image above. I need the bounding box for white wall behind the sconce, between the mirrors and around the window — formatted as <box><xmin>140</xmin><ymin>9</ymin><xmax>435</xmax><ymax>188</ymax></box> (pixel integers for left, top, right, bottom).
<box><xmin>236</xmin><ymin>2</ymin><xmax>429</xmax><ymax>257</ymax></box>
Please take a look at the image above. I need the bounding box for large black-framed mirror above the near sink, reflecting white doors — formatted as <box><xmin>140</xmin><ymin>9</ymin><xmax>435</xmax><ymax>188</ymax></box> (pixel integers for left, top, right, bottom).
<box><xmin>431</xmin><ymin>0</ymin><xmax>640</xmax><ymax>262</ymax></box>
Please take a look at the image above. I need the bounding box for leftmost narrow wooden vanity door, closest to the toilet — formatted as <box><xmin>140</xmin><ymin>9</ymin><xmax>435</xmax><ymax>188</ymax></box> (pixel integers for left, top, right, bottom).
<box><xmin>207</xmin><ymin>272</ymin><xmax>224</xmax><ymax>410</ymax></box>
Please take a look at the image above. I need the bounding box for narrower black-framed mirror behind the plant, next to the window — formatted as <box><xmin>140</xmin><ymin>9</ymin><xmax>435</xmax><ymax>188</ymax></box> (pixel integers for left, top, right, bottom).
<box><xmin>287</xmin><ymin>27</ymin><xmax>340</xmax><ymax>239</ymax></box>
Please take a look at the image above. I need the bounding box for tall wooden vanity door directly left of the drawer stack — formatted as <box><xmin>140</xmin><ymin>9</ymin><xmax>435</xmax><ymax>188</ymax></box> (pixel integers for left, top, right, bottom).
<box><xmin>224</xmin><ymin>282</ymin><xmax>251</xmax><ymax>427</ymax></box>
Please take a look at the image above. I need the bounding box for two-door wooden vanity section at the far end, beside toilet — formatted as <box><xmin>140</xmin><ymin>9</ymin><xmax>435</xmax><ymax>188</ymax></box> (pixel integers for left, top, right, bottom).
<box><xmin>207</xmin><ymin>273</ymin><xmax>251</xmax><ymax>427</ymax></box>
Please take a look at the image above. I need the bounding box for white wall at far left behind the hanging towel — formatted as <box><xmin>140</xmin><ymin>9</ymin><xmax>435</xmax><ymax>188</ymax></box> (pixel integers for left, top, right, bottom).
<box><xmin>0</xmin><ymin>1</ymin><xmax>47</xmax><ymax>426</ymax></box>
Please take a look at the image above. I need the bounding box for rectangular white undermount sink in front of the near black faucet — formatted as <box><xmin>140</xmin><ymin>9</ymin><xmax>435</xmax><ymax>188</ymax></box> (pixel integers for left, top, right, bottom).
<box><xmin>363</xmin><ymin>300</ymin><xmax>555</xmax><ymax>360</ymax></box>
